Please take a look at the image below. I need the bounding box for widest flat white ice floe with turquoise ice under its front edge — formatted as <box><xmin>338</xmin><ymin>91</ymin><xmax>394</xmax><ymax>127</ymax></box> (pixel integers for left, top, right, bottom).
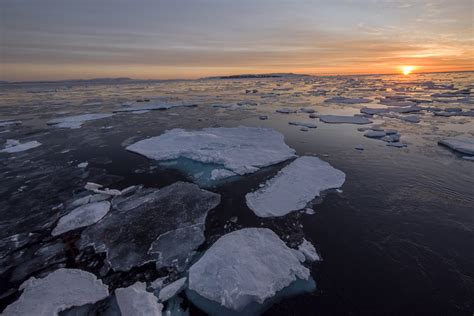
<box><xmin>126</xmin><ymin>126</ymin><xmax>295</xmax><ymax>175</ymax></box>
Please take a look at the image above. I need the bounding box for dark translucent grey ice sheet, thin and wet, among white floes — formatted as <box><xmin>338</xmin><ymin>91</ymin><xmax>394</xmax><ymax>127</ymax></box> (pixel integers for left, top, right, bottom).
<box><xmin>79</xmin><ymin>182</ymin><xmax>220</xmax><ymax>271</ymax></box>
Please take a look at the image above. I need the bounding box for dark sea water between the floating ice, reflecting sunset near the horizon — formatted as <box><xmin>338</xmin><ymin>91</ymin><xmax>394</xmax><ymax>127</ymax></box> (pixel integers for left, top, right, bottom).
<box><xmin>0</xmin><ymin>73</ymin><xmax>474</xmax><ymax>315</ymax></box>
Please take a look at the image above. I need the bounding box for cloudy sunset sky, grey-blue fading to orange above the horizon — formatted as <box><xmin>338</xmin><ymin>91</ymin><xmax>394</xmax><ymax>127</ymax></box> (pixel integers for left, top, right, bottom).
<box><xmin>0</xmin><ymin>0</ymin><xmax>474</xmax><ymax>81</ymax></box>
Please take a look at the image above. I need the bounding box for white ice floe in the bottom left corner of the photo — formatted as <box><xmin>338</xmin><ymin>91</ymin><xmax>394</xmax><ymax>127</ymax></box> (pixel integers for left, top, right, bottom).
<box><xmin>2</xmin><ymin>269</ymin><xmax>109</xmax><ymax>316</ymax></box>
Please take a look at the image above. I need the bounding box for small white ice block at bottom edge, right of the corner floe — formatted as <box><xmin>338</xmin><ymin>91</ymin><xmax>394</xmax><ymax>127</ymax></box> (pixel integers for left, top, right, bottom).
<box><xmin>115</xmin><ymin>282</ymin><xmax>163</xmax><ymax>316</ymax></box>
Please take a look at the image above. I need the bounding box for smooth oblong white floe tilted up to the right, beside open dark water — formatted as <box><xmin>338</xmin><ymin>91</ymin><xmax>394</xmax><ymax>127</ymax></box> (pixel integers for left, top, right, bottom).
<box><xmin>245</xmin><ymin>156</ymin><xmax>346</xmax><ymax>217</ymax></box>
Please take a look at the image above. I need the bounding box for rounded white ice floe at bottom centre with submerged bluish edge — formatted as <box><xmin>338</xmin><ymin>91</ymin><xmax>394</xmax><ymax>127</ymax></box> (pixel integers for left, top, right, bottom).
<box><xmin>186</xmin><ymin>228</ymin><xmax>315</xmax><ymax>315</ymax></box>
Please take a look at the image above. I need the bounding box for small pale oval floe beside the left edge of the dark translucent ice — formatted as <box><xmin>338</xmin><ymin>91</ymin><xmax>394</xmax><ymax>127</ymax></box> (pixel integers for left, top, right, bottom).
<box><xmin>51</xmin><ymin>201</ymin><xmax>110</xmax><ymax>236</ymax></box>
